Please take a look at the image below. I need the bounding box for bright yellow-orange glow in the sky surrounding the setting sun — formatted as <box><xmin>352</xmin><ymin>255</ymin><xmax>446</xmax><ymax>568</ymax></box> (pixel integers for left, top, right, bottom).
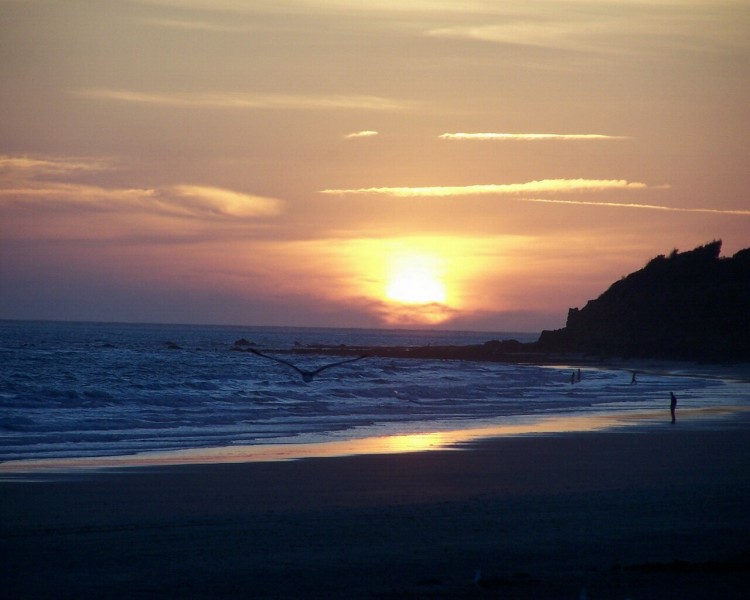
<box><xmin>334</xmin><ymin>235</ymin><xmax>536</xmax><ymax>327</ymax></box>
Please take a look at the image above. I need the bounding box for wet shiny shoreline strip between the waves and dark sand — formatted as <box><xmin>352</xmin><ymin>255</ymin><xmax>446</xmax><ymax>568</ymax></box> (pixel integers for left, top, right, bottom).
<box><xmin>0</xmin><ymin>406</ymin><xmax>750</xmax><ymax>483</ymax></box>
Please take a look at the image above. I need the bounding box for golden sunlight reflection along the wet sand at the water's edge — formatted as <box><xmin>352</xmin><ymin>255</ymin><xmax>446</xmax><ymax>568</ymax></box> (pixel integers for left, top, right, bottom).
<box><xmin>0</xmin><ymin>406</ymin><xmax>748</xmax><ymax>475</ymax></box>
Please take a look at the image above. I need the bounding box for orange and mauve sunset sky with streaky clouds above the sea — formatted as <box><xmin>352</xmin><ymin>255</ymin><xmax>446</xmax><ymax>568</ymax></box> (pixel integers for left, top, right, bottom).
<box><xmin>0</xmin><ymin>0</ymin><xmax>750</xmax><ymax>332</ymax></box>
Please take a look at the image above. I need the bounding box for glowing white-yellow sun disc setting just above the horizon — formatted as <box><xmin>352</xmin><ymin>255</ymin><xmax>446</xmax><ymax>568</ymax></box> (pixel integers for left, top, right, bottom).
<box><xmin>385</xmin><ymin>255</ymin><xmax>447</xmax><ymax>304</ymax></box>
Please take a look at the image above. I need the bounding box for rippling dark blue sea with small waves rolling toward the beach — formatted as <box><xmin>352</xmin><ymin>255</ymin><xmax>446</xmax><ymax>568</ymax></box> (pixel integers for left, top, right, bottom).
<box><xmin>0</xmin><ymin>321</ymin><xmax>748</xmax><ymax>462</ymax></box>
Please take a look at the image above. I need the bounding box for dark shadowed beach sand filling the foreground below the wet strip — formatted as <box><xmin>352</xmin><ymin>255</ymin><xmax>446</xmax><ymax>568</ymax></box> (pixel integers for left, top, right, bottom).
<box><xmin>0</xmin><ymin>423</ymin><xmax>750</xmax><ymax>600</ymax></box>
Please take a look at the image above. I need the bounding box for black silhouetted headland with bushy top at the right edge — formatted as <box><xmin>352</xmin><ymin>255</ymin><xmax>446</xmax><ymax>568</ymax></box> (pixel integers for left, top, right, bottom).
<box><xmin>535</xmin><ymin>240</ymin><xmax>750</xmax><ymax>360</ymax></box>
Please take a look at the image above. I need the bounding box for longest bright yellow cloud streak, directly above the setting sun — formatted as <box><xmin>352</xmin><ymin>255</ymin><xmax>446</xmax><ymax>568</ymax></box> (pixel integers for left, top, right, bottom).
<box><xmin>321</xmin><ymin>179</ymin><xmax>649</xmax><ymax>198</ymax></box>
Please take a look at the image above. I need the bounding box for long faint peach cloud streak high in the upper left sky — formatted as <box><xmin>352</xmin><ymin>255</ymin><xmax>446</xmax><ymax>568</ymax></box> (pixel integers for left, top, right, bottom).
<box><xmin>70</xmin><ymin>88</ymin><xmax>410</xmax><ymax>111</ymax></box>
